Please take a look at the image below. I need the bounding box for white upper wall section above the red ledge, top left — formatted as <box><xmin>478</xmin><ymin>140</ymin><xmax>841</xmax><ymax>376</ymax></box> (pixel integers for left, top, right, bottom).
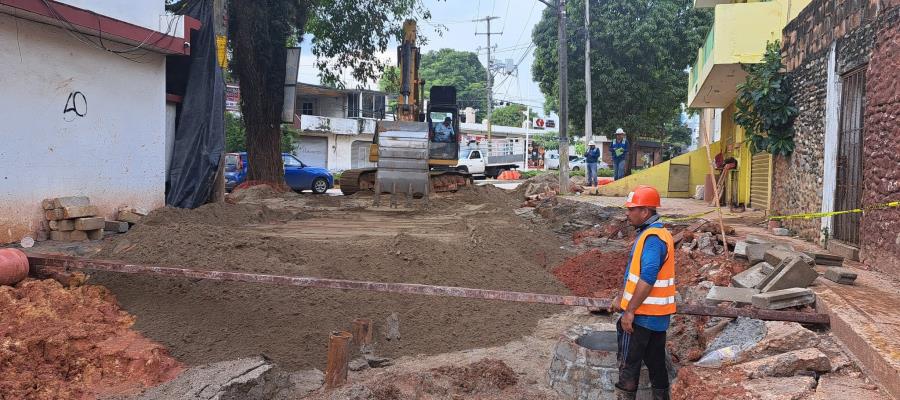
<box><xmin>56</xmin><ymin>0</ymin><xmax>165</xmax><ymax>32</ymax></box>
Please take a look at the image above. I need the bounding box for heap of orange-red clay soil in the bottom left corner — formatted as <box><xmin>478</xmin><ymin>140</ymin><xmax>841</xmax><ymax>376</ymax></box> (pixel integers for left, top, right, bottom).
<box><xmin>0</xmin><ymin>279</ymin><xmax>183</xmax><ymax>399</ymax></box>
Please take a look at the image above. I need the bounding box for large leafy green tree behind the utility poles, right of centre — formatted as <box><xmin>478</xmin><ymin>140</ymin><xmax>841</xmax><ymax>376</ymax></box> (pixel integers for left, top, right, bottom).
<box><xmin>532</xmin><ymin>0</ymin><xmax>712</xmax><ymax>149</ymax></box>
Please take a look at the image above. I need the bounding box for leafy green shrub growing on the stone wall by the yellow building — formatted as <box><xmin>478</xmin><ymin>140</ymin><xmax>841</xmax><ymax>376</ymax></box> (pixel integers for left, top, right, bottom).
<box><xmin>734</xmin><ymin>41</ymin><xmax>799</xmax><ymax>156</ymax></box>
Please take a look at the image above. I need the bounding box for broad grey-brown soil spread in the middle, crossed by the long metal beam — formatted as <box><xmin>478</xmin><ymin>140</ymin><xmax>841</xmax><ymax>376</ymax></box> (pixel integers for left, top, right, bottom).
<box><xmin>91</xmin><ymin>188</ymin><xmax>568</xmax><ymax>370</ymax></box>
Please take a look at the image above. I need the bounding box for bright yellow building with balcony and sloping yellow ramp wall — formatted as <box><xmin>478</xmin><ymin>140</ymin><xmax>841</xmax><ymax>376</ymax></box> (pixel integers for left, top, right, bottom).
<box><xmin>601</xmin><ymin>0</ymin><xmax>811</xmax><ymax>209</ymax></box>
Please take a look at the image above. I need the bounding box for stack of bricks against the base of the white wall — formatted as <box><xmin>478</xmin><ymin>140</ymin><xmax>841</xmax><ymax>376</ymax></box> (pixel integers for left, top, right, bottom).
<box><xmin>39</xmin><ymin>196</ymin><xmax>106</xmax><ymax>242</ymax></box>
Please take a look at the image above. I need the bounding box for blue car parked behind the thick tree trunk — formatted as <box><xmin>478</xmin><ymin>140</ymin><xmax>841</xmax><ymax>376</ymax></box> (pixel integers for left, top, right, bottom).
<box><xmin>225</xmin><ymin>152</ymin><xmax>334</xmax><ymax>194</ymax></box>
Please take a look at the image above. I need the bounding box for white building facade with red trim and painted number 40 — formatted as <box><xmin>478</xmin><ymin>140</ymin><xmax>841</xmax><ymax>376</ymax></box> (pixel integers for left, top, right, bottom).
<box><xmin>0</xmin><ymin>0</ymin><xmax>199</xmax><ymax>243</ymax></box>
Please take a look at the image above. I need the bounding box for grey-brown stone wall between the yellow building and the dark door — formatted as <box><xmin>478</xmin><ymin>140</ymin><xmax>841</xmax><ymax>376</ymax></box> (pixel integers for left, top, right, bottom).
<box><xmin>772</xmin><ymin>0</ymin><xmax>880</xmax><ymax>240</ymax></box>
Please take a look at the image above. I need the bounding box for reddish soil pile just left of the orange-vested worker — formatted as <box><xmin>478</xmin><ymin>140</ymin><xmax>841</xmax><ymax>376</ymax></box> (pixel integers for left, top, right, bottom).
<box><xmin>553</xmin><ymin>249</ymin><xmax>629</xmax><ymax>299</ymax></box>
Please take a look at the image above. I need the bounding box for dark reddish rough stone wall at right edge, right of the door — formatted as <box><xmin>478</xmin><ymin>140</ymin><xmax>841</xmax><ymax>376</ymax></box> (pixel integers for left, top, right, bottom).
<box><xmin>860</xmin><ymin>7</ymin><xmax>900</xmax><ymax>277</ymax></box>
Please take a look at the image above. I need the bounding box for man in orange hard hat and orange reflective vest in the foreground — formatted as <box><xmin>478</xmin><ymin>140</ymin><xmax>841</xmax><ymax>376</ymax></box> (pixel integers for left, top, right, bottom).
<box><xmin>610</xmin><ymin>185</ymin><xmax>675</xmax><ymax>400</ymax></box>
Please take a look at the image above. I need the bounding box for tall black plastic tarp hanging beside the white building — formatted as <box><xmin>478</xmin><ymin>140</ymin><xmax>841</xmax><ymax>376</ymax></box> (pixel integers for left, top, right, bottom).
<box><xmin>166</xmin><ymin>0</ymin><xmax>225</xmax><ymax>208</ymax></box>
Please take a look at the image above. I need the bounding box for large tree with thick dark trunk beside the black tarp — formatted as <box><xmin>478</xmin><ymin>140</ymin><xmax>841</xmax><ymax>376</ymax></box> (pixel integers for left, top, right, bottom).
<box><xmin>228</xmin><ymin>0</ymin><xmax>430</xmax><ymax>185</ymax></box>
